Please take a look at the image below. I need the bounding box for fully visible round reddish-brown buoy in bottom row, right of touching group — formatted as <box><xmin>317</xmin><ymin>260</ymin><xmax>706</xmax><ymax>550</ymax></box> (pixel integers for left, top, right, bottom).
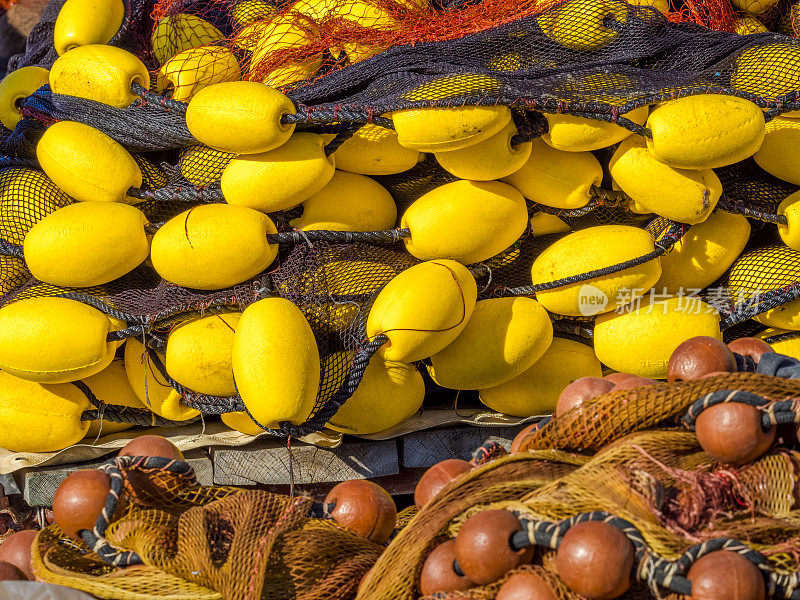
<box><xmin>556</xmin><ymin>521</ymin><xmax>634</xmax><ymax>600</ymax></box>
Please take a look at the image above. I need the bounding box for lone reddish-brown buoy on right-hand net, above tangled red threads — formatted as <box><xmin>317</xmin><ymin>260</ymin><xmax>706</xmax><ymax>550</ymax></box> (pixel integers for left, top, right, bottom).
<box><xmin>695</xmin><ymin>402</ymin><xmax>775</xmax><ymax>467</ymax></box>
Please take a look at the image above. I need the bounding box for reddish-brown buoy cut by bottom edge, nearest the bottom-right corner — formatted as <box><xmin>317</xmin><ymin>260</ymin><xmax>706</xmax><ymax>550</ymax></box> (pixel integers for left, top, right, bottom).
<box><xmin>686</xmin><ymin>550</ymin><xmax>766</xmax><ymax>600</ymax></box>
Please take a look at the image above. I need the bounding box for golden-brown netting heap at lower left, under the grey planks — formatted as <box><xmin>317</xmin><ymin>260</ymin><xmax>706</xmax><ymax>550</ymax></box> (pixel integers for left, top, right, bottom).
<box><xmin>33</xmin><ymin>457</ymin><xmax>382</xmax><ymax>600</ymax></box>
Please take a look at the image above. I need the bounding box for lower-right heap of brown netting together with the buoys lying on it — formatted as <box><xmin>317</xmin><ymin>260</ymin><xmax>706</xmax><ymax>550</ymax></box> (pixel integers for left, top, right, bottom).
<box><xmin>358</xmin><ymin>354</ymin><xmax>800</xmax><ymax>600</ymax></box>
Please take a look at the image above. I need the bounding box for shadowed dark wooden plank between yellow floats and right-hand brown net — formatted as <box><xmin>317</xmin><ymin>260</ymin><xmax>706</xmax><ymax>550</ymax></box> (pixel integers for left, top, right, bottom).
<box><xmin>401</xmin><ymin>425</ymin><xmax>527</xmax><ymax>468</ymax></box>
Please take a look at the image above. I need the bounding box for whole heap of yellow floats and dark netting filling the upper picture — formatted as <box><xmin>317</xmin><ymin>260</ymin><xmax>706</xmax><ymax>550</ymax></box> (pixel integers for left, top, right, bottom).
<box><xmin>0</xmin><ymin>0</ymin><xmax>800</xmax><ymax>451</ymax></box>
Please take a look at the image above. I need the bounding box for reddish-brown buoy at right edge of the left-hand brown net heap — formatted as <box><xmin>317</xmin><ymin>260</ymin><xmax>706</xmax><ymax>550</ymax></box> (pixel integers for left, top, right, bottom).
<box><xmin>325</xmin><ymin>479</ymin><xmax>397</xmax><ymax>544</ymax></box>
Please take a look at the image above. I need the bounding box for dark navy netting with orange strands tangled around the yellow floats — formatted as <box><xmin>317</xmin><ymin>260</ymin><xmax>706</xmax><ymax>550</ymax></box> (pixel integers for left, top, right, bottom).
<box><xmin>0</xmin><ymin>0</ymin><xmax>800</xmax><ymax>436</ymax></box>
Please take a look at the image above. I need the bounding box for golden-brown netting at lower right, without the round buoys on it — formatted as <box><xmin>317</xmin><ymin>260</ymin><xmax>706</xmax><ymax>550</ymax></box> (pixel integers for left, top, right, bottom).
<box><xmin>357</xmin><ymin>354</ymin><xmax>800</xmax><ymax>600</ymax></box>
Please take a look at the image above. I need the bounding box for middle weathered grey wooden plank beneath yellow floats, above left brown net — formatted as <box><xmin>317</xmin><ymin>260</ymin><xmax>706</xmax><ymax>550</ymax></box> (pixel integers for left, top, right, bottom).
<box><xmin>211</xmin><ymin>440</ymin><xmax>400</xmax><ymax>485</ymax></box>
